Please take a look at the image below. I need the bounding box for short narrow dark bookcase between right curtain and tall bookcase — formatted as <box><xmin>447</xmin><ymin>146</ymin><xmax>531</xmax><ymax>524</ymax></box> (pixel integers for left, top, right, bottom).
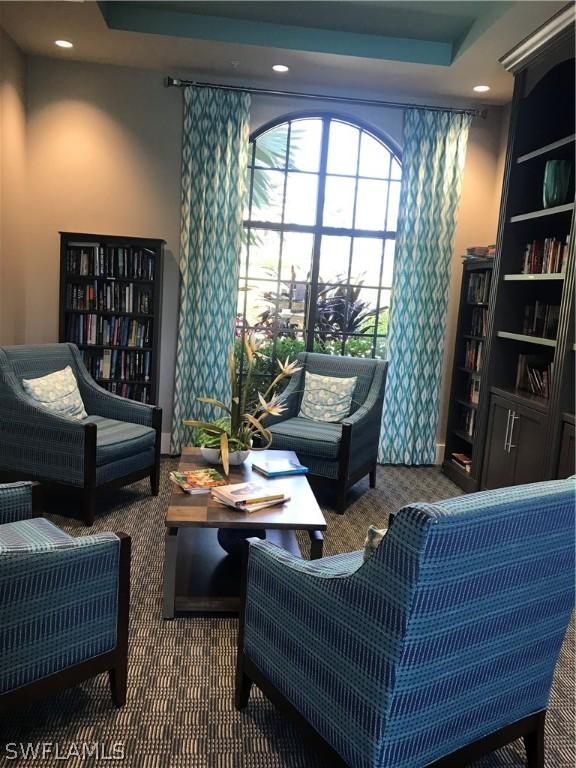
<box><xmin>442</xmin><ymin>257</ymin><xmax>494</xmax><ymax>491</ymax></box>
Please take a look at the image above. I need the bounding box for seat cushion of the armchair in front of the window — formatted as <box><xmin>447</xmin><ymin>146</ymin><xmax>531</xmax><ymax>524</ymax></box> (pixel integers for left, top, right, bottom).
<box><xmin>269</xmin><ymin>416</ymin><xmax>342</xmax><ymax>459</ymax></box>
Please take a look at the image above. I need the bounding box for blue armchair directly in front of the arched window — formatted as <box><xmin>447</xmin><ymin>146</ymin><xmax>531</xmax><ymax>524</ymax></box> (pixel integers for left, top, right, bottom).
<box><xmin>266</xmin><ymin>352</ymin><xmax>388</xmax><ymax>512</ymax></box>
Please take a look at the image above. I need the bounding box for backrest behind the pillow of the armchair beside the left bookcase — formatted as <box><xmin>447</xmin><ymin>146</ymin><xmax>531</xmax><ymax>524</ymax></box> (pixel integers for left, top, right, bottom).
<box><xmin>0</xmin><ymin>344</ymin><xmax>89</xmax><ymax>400</ymax></box>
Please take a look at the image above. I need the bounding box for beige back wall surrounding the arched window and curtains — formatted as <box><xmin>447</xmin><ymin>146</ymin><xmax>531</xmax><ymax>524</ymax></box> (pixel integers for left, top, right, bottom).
<box><xmin>2</xmin><ymin>52</ymin><xmax>501</xmax><ymax>456</ymax></box>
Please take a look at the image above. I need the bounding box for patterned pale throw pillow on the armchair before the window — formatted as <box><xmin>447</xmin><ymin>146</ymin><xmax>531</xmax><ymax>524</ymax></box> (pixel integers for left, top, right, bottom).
<box><xmin>298</xmin><ymin>371</ymin><xmax>357</xmax><ymax>422</ymax></box>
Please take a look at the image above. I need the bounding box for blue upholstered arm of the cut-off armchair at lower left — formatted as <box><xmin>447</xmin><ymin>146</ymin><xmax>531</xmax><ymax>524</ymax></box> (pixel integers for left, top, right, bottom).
<box><xmin>0</xmin><ymin>520</ymin><xmax>129</xmax><ymax>694</ymax></box>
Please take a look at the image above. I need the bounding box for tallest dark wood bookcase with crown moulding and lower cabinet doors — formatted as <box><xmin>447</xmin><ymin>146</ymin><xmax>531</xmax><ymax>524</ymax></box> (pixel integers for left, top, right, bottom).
<box><xmin>445</xmin><ymin>6</ymin><xmax>576</xmax><ymax>490</ymax></box>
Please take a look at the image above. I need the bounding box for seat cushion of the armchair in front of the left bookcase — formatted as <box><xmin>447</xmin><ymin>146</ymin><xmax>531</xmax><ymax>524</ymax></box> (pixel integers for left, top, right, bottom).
<box><xmin>84</xmin><ymin>416</ymin><xmax>156</xmax><ymax>467</ymax></box>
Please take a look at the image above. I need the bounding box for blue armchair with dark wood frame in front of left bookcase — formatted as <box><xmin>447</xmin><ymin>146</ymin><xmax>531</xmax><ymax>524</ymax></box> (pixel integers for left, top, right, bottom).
<box><xmin>0</xmin><ymin>344</ymin><xmax>162</xmax><ymax>525</ymax></box>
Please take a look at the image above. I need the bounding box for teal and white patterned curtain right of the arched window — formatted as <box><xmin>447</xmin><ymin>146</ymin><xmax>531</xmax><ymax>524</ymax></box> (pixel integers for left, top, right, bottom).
<box><xmin>378</xmin><ymin>109</ymin><xmax>471</xmax><ymax>464</ymax></box>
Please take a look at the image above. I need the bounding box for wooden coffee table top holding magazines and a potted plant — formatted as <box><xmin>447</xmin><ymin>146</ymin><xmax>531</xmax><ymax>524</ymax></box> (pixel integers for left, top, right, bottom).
<box><xmin>166</xmin><ymin>448</ymin><xmax>326</xmax><ymax>531</ymax></box>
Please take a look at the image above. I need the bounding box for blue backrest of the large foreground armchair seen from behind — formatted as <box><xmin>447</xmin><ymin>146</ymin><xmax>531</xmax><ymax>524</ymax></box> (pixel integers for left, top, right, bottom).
<box><xmin>368</xmin><ymin>479</ymin><xmax>575</xmax><ymax>766</ymax></box>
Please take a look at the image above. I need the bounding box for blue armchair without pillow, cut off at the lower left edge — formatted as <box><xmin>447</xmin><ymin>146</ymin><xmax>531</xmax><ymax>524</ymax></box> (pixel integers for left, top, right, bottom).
<box><xmin>0</xmin><ymin>482</ymin><xmax>130</xmax><ymax>712</ymax></box>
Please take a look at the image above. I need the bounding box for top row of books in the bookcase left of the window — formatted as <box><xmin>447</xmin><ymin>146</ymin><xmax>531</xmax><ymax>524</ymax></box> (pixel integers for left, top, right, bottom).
<box><xmin>66</xmin><ymin>243</ymin><xmax>156</xmax><ymax>280</ymax></box>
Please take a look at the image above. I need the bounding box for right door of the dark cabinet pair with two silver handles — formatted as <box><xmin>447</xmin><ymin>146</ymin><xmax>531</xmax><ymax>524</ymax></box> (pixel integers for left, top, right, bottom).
<box><xmin>508</xmin><ymin>406</ymin><xmax>546</xmax><ymax>485</ymax></box>
